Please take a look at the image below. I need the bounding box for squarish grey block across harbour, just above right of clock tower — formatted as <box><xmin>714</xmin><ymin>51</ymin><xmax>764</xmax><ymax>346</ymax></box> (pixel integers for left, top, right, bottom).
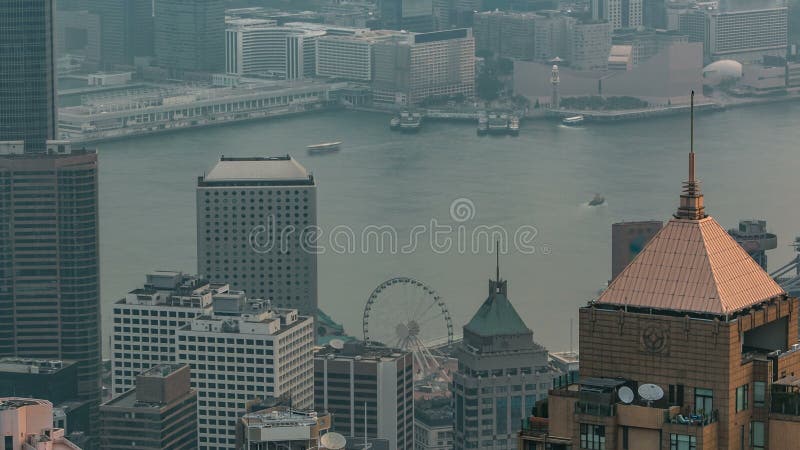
<box><xmin>566</xmin><ymin>21</ymin><xmax>612</xmax><ymax>70</ymax></box>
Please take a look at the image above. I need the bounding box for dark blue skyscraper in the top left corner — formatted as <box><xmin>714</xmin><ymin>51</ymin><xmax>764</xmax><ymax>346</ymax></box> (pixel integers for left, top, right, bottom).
<box><xmin>0</xmin><ymin>0</ymin><xmax>58</xmax><ymax>152</ymax></box>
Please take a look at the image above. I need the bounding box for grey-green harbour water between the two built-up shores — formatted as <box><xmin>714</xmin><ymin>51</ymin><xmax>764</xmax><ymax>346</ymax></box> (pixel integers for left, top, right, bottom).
<box><xmin>98</xmin><ymin>103</ymin><xmax>800</xmax><ymax>351</ymax></box>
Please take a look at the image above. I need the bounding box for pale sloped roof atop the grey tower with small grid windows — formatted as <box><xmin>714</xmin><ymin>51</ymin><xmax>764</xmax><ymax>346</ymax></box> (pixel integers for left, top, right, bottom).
<box><xmin>201</xmin><ymin>155</ymin><xmax>314</xmax><ymax>184</ymax></box>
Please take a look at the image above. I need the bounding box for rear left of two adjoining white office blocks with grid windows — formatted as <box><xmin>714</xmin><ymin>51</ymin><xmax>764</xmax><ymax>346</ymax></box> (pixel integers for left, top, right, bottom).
<box><xmin>111</xmin><ymin>271</ymin><xmax>217</xmax><ymax>396</ymax></box>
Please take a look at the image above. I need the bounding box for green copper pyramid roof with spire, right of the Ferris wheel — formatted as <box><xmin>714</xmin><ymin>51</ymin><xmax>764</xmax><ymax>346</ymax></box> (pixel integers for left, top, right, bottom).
<box><xmin>464</xmin><ymin>281</ymin><xmax>531</xmax><ymax>336</ymax></box>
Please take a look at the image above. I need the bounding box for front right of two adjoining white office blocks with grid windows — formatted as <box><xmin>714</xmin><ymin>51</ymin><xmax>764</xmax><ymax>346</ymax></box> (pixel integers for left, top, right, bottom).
<box><xmin>176</xmin><ymin>291</ymin><xmax>314</xmax><ymax>450</ymax></box>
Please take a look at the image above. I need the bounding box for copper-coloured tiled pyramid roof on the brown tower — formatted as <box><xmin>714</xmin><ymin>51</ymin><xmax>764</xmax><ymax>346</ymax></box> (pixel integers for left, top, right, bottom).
<box><xmin>596</xmin><ymin>217</ymin><xmax>784</xmax><ymax>315</ymax></box>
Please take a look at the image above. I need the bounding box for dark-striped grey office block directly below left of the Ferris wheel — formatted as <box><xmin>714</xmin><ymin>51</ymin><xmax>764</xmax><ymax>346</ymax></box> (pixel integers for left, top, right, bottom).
<box><xmin>314</xmin><ymin>342</ymin><xmax>414</xmax><ymax>450</ymax></box>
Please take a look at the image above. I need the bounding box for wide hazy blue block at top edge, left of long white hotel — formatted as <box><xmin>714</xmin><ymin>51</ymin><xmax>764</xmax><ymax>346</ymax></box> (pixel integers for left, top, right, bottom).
<box><xmin>154</xmin><ymin>0</ymin><xmax>225</xmax><ymax>76</ymax></box>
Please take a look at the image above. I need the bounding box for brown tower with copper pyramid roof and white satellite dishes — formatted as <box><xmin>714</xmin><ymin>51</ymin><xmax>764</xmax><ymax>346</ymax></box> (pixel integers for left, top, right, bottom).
<box><xmin>521</xmin><ymin>123</ymin><xmax>800</xmax><ymax>450</ymax></box>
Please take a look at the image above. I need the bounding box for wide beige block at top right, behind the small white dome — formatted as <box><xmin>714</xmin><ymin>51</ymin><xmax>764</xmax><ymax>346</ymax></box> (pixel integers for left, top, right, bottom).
<box><xmin>707</xmin><ymin>6</ymin><xmax>789</xmax><ymax>63</ymax></box>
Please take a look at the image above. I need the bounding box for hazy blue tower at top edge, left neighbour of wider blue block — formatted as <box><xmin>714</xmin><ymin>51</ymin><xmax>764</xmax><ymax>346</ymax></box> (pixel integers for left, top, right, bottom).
<box><xmin>89</xmin><ymin>0</ymin><xmax>154</xmax><ymax>69</ymax></box>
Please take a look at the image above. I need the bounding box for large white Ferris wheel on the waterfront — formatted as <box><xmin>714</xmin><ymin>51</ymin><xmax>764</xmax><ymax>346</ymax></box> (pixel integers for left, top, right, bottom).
<box><xmin>363</xmin><ymin>277</ymin><xmax>453</xmax><ymax>377</ymax></box>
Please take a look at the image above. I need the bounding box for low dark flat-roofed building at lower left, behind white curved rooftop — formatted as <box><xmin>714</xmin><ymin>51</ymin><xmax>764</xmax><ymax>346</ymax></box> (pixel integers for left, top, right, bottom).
<box><xmin>0</xmin><ymin>357</ymin><xmax>91</xmax><ymax>434</ymax></box>
